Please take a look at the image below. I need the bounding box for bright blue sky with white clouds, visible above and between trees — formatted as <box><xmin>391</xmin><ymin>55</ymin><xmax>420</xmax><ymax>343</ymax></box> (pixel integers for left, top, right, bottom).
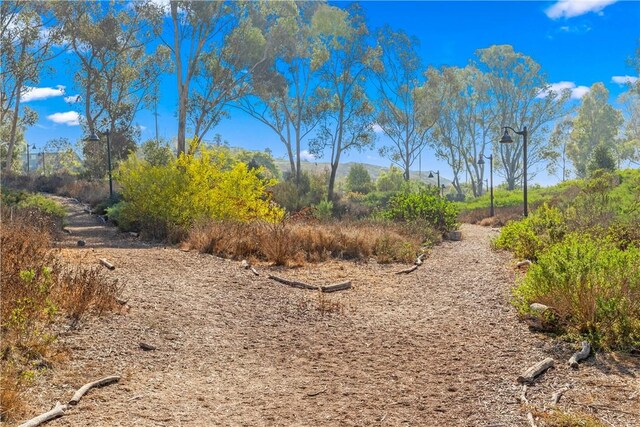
<box><xmin>23</xmin><ymin>0</ymin><xmax>640</xmax><ymax>183</ymax></box>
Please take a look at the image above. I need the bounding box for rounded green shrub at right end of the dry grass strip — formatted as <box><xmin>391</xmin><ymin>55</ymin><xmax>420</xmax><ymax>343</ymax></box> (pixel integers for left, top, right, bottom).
<box><xmin>382</xmin><ymin>189</ymin><xmax>458</xmax><ymax>233</ymax></box>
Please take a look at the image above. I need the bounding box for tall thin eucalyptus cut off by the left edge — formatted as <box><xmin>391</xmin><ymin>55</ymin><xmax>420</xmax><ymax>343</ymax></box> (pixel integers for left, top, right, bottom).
<box><xmin>0</xmin><ymin>0</ymin><xmax>60</xmax><ymax>171</ymax></box>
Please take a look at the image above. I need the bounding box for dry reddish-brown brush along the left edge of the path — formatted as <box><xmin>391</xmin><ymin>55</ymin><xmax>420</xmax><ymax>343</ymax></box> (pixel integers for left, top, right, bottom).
<box><xmin>0</xmin><ymin>209</ymin><xmax>120</xmax><ymax>420</ymax></box>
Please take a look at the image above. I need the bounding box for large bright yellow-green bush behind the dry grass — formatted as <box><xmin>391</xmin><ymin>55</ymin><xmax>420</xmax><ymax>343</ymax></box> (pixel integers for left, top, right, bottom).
<box><xmin>117</xmin><ymin>147</ymin><xmax>282</xmax><ymax>237</ymax></box>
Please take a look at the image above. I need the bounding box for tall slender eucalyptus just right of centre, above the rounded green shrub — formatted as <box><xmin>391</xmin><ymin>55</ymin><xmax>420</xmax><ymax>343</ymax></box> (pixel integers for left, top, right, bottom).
<box><xmin>375</xmin><ymin>26</ymin><xmax>443</xmax><ymax>181</ymax></box>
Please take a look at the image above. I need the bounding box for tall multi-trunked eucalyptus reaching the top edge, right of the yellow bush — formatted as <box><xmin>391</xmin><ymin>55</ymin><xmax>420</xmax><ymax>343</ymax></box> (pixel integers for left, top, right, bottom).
<box><xmin>236</xmin><ymin>1</ymin><xmax>330</xmax><ymax>185</ymax></box>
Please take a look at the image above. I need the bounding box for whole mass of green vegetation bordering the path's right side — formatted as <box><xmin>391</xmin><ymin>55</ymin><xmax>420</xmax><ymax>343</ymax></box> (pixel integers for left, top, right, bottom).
<box><xmin>494</xmin><ymin>170</ymin><xmax>640</xmax><ymax>350</ymax></box>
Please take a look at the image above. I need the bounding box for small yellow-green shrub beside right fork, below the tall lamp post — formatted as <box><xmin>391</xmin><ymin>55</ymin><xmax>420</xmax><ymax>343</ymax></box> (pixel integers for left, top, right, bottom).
<box><xmin>493</xmin><ymin>203</ymin><xmax>567</xmax><ymax>261</ymax></box>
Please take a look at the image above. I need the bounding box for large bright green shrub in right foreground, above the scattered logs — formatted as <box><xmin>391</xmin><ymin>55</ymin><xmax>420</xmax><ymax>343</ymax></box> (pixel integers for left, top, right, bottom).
<box><xmin>514</xmin><ymin>234</ymin><xmax>640</xmax><ymax>349</ymax></box>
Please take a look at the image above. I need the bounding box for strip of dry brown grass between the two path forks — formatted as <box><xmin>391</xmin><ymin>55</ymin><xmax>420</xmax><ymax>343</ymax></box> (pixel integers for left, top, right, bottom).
<box><xmin>187</xmin><ymin>221</ymin><xmax>437</xmax><ymax>265</ymax></box>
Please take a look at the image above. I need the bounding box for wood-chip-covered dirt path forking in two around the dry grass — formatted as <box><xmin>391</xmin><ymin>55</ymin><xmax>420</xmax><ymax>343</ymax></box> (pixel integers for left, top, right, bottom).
<box><xmin>22</xmin><ymin>201</ymin><xmax>640</xmax><ymax>426</ymax></box>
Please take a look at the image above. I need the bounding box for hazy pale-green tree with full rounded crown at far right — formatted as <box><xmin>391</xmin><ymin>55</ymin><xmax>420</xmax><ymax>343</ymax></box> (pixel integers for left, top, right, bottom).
<box><xmin>567</xmin><ymin>82</ymin><xmax>624</xmax><ymax>178</ymax></box>
